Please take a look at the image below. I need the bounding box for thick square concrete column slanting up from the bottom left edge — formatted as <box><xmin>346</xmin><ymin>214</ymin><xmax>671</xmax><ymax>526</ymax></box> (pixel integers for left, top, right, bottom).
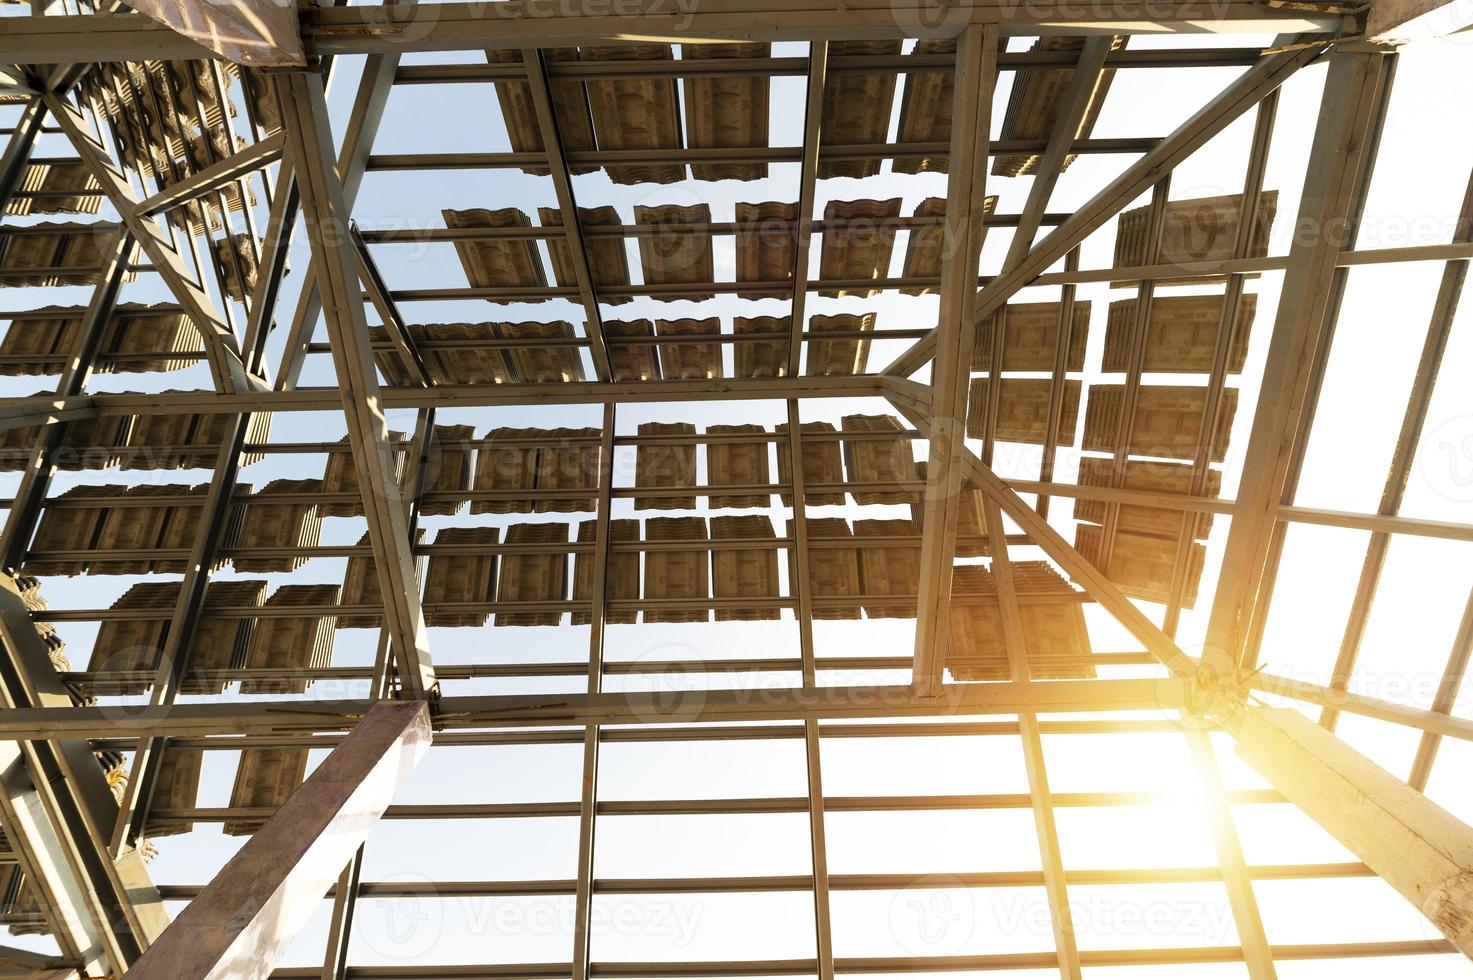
<box><xmin>128</xmin><ymin>701</ymin><xmax>432</xmax><ymax>980</ymax></box>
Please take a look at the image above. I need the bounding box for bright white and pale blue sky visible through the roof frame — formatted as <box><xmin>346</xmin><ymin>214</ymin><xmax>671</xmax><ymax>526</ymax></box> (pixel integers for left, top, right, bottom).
<box><xmin>0</xmin><ymin>11</ymin><xmax>1473</xmax><ymax>980</ymax></box>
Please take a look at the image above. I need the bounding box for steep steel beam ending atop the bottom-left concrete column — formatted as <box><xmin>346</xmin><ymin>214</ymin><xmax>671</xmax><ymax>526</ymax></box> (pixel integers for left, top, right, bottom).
<box><xmin>277</xmin><ymin>72</ymin><xmax>436</xmax><ymax>697</ymax></box>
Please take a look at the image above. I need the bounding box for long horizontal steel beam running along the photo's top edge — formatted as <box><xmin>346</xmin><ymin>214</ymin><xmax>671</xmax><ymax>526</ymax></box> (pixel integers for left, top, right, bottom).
<box><xmin>0</xmin><ymin>0</ymin><xmax>1342</xmax><ymax>65</ymax></box>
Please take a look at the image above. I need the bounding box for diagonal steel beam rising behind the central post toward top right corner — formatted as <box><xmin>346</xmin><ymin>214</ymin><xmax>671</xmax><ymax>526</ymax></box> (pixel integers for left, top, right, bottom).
<box><xmin>884</xmin><ymin>39</ymin><xmax>1323</xmax><ymax>377</ymax></box>
